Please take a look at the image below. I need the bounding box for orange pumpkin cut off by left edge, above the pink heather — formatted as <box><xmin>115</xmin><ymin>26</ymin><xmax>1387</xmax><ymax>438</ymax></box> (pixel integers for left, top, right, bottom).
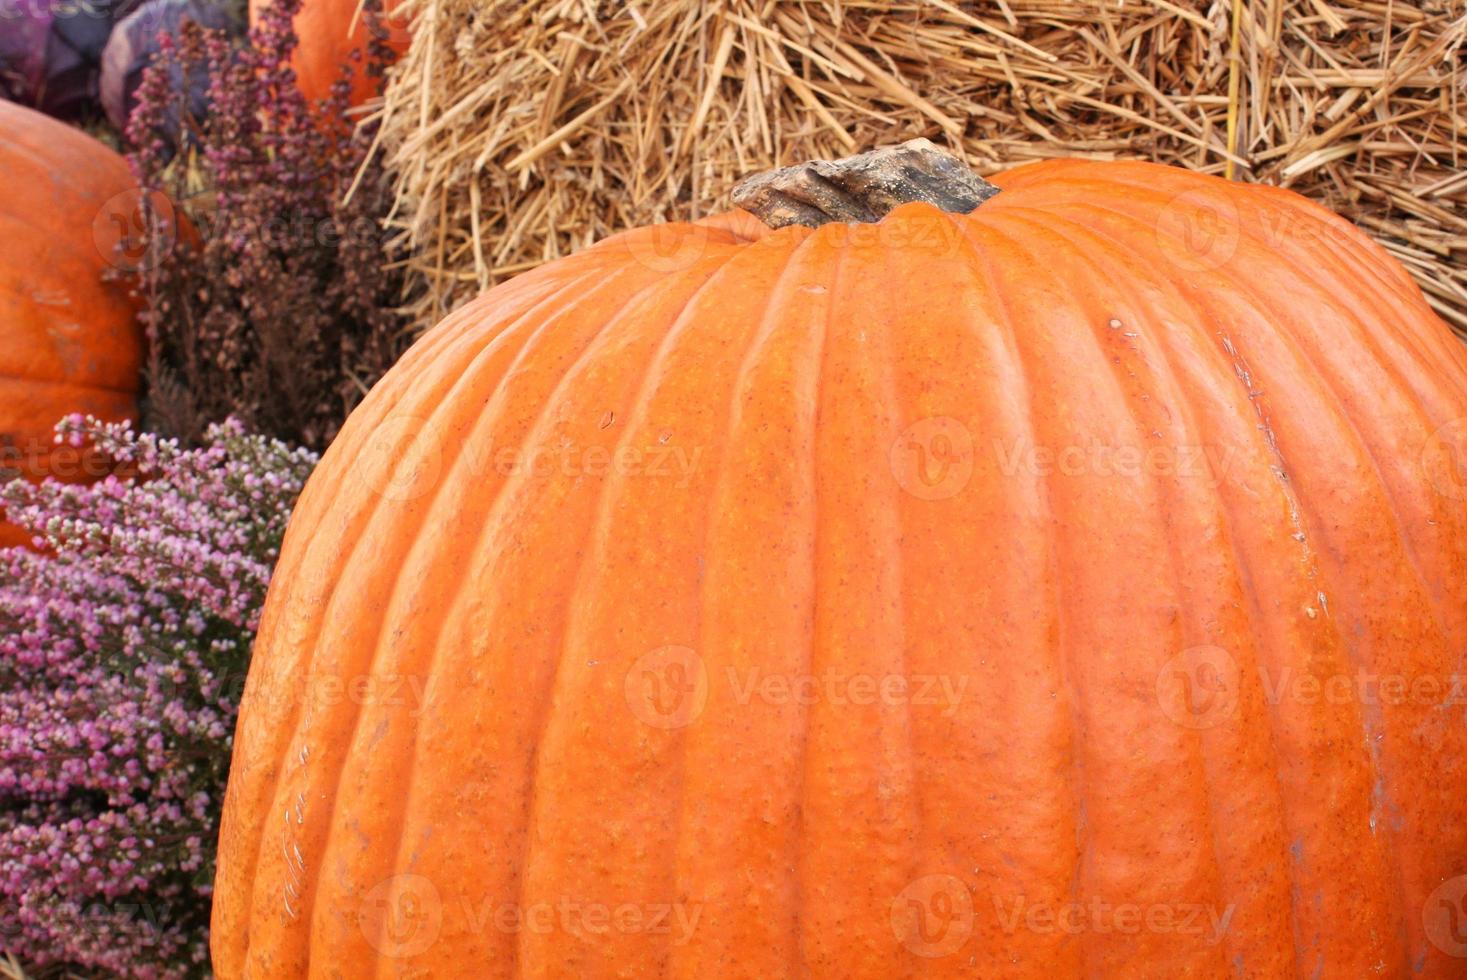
<box><xmin>0</xmin><ymin>101</ymin><xmax>142</xmax><ymax>546</ymax></box>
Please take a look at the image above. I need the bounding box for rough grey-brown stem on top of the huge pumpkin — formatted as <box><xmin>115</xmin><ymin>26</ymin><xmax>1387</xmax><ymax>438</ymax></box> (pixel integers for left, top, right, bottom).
<box><xmin>734</xmin><ymin>139</ymin><xmax>999</xmax><ymax>227</ymax></box>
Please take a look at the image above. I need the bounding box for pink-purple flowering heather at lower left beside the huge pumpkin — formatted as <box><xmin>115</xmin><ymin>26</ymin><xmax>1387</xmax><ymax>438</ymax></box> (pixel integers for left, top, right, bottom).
<box><xmin>0</xmin><ymin>417</ymin><xmax>315</xmax><ymax>977</ymax></box>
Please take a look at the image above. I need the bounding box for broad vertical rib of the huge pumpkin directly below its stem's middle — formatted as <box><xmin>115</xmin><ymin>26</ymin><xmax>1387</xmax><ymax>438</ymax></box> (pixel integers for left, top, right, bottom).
<box><xmin>804</xmin><ymin>229</ymin><xmax>918</xmax><ymax>976</ymax></box>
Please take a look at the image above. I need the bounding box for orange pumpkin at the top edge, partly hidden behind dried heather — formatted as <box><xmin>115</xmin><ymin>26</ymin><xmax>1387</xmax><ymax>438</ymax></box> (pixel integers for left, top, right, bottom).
<box><xmin>249</xmin><ymin>0</ymin><xmax>411</xmax><ymax>106</ymax></box>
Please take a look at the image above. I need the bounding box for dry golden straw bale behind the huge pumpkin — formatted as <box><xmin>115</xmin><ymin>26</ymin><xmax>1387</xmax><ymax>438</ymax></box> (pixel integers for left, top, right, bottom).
<box><xmin>369</xmin><ymin>0</ymin><xmax>1467</xmax><ymax>340</ymax></box>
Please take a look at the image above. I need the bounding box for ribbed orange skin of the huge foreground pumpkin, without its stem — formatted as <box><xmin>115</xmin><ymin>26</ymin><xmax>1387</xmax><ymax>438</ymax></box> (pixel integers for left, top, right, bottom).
<box><xmin>213</xmin><ymin>161</ymin><xmax>1467</xmax><ymax>980</ymax></box>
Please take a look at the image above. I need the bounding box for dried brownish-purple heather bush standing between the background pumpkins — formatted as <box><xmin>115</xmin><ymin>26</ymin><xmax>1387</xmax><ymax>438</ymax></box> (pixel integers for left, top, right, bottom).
<box><xmin>128</xmin><ymin>0</ymin><xmax>409</xmax><ymax>449</ymax></box>
